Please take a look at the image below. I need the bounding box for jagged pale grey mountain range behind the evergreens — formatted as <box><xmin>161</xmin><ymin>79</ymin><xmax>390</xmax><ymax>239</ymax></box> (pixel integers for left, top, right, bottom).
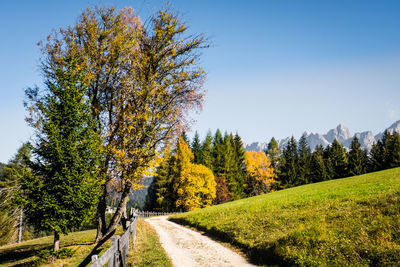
<box><xmin>246</xmin><ymin>120</ymin><xmax>400</xmax><ymax>151</ymax></box>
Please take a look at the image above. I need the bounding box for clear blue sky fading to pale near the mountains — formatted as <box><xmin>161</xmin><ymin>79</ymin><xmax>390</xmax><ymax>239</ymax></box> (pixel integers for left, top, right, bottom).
<box><xmin>0</xmin><ymin>0</ymin><xmax>400</xmax><ymax>162</ymax></box>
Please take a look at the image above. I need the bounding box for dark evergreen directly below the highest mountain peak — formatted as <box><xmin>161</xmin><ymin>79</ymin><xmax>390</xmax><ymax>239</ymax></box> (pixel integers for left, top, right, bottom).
<box><xmin>328</xmin><ymin>139</ymin><xmax>348</xmax><ymax>178</ymax></box>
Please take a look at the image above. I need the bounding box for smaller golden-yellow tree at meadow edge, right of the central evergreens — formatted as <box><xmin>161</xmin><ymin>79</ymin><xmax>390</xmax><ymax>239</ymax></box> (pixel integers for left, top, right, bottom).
<box><xmin>245</xmin><ymin>151</ymin><xmax>276</xmax><ymax>196</ymax></box>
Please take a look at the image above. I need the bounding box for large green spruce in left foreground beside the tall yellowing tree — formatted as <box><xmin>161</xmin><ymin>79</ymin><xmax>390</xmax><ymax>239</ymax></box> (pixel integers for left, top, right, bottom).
<box><xmin>20</xmin><ymin>52</ymin><xmax>101</xmax><ymax>251</ymax></box>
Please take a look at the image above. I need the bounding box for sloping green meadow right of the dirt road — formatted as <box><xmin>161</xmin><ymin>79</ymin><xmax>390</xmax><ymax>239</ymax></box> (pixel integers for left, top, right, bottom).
<box><xmin>171</xmin><ymin>168</ymin><xmax>400</xmax><ymax>266</ymax></box>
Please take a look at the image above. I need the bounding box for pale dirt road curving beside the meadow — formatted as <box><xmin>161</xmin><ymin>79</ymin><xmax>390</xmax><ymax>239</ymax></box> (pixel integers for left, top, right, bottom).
<box><xmin>146</xmin><ymin>216</ymin><xmax>254</xmax><ymax>267</ymax></box>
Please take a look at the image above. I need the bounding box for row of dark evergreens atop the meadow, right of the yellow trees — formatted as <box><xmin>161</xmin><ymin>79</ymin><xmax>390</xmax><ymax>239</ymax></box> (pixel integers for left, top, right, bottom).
<box><xmin>265</xmin><ymin>131</ymin><xmax>400</xmax><ymax>188</ymax></box>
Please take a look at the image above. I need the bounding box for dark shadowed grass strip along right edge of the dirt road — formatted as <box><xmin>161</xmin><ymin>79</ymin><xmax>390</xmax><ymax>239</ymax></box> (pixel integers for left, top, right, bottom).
<box><xmin>168</xmin><ymin>218</ymin><xmax>291</xmax><ymax>266</ymax></box>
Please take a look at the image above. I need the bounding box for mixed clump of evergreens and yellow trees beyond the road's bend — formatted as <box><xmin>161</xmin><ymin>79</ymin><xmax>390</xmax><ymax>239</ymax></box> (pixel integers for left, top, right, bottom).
<box><xmin>146</xmin><ymin>129</ymin><xmax>275</xmax><ymax>211</ymax></box>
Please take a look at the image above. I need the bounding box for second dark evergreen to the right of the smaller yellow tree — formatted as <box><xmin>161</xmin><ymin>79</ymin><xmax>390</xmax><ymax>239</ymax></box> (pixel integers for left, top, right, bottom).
<box><xmin>279</xmin><ymin>136</ymin><xmax>299</xmax><ymax>187</ymax></box>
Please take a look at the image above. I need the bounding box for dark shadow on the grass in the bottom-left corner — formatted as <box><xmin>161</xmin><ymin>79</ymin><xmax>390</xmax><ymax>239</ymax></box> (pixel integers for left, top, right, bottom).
<box><xmin>0</xmin><ymin>244</ymin><xmax>52</xmax><ymax>266</ymax></box>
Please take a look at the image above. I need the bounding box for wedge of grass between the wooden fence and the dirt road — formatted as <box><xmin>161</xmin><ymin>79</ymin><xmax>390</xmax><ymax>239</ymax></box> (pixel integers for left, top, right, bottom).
<box><xmin>127</xmin><ymin>219</ymin><xmax>172</xmax><ymax>267</ymax></box>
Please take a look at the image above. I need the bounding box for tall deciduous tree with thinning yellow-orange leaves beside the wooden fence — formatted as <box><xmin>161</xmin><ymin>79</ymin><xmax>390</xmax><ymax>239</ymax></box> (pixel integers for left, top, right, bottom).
<box><xmin>36</xmin><ymin>5</ymin><xmax>206</xmax><ymax>241</ymax></box>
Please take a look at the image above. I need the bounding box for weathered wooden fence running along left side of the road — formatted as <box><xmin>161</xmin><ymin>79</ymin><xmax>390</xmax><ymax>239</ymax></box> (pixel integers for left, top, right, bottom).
<box><xmin>89</xmin><ymin>209</ymin><xmax>180</xmax><ymax>267</ymax></box>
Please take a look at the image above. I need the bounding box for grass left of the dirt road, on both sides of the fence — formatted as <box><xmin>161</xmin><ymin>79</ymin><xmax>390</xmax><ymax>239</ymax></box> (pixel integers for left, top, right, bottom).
<box><xmin>0</xmin><ymin>220</ymin><xmax>172</xmax><ymax>267</ymax></box>
